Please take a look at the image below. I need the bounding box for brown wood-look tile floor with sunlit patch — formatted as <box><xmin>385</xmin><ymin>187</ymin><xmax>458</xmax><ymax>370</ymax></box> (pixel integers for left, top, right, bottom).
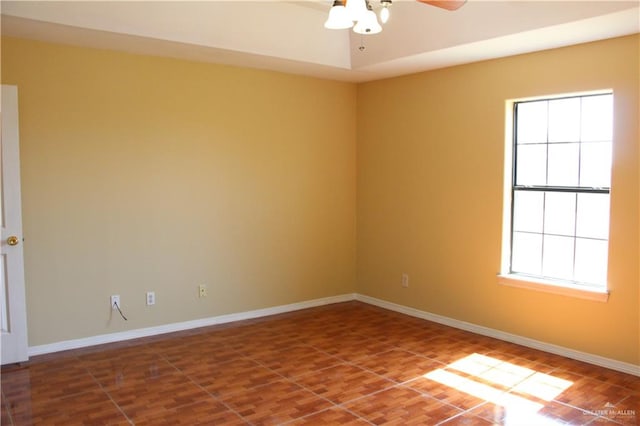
<box><xmin>0</xmin><ymin>302</ymin><xmax>640</xmax><ymax>426</ymax></box>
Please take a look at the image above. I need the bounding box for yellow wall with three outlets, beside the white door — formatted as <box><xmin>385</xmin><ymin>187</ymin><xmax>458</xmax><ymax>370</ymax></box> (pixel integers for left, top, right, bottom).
<box><xmin>2</xmin><ymin>39</ymin><xmax>356</xmax><ymax>346</ymax></box>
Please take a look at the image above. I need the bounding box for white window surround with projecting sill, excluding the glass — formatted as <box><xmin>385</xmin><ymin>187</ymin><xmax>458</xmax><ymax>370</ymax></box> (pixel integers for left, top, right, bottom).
<box><xmin>498</xmin><ymin>90</ymin><xmax>613</xmax><ymax>302</ymax></box>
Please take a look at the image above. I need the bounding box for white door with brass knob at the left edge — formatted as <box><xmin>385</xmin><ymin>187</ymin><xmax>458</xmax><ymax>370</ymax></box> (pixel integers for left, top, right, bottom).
<box><xmin>0</xmin><ymin>85</ymin><xmax>29</xmax><ymax>365</ymax></box>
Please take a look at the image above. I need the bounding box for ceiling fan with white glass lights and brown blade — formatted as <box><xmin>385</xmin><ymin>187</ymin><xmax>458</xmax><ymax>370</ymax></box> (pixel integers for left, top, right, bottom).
<box><xmin>324</xmin><ymin>0</ymin><xmax>467</xmax><ymax>34</ymax></box>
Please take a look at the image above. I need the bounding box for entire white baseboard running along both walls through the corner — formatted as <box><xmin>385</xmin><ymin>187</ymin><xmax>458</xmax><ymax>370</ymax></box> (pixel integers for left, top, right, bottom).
<box><xmin>29</xmin><ymin>293</ymin><xmax>640</xmax><ymax>376</ymax></box>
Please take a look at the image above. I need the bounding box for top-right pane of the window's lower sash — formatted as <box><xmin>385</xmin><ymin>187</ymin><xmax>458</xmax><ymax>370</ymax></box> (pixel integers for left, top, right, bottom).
<box><xmin>576</xmin><ymin>194</ymin><xmax>609</xmax><ymax>240</ymax></box>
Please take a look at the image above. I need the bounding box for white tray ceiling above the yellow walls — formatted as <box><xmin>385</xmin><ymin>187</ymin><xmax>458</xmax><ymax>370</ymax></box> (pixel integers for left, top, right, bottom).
<box><xmin>0</xmin><ymin>0</ymin><xmax>640</xmax><ymax>82</ymax></box>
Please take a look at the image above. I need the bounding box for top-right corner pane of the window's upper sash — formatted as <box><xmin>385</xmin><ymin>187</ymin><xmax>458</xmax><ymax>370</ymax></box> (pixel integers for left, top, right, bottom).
<box><xmin>581</xmin><ymin>95</ymin><xmax>613</xmax><ymax>142</ymax></box>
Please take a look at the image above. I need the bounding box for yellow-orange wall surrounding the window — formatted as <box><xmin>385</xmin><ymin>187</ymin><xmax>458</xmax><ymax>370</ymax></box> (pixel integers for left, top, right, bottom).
<box><xmin>357</xmin><ymin>35</ymin><xmax>640</xmax><ymax>365</ymax></box>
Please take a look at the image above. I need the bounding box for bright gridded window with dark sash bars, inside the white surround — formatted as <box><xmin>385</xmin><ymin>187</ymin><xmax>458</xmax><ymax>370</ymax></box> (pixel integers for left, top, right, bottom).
<box><xmin>508</xmin><ymin>93</ymin><xmax>613</xmax><ymax>292</ymax></box>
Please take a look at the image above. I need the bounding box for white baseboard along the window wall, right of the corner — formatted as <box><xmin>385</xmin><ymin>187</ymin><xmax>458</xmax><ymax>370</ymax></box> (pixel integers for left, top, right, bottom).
<box><xmin>356</xmin><ymin>294</ymin><xmax>640</xmax><ymax>376</ymax></box>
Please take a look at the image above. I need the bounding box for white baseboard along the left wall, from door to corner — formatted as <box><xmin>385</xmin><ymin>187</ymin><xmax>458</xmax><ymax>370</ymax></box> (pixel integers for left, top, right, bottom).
<box><xmin>28</xmin><ymin>294</ymin><xmax>356</xmax><ymax>356</ymax></box>
